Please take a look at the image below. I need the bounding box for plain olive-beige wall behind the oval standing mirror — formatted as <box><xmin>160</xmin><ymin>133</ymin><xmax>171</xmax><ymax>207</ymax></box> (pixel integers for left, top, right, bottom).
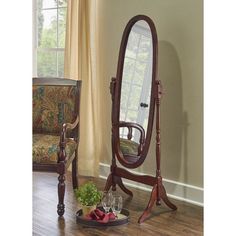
<box><xmin>99</xmin><ymin>0</ymin><xmax>203</xmax><ymax>187</ymax></box>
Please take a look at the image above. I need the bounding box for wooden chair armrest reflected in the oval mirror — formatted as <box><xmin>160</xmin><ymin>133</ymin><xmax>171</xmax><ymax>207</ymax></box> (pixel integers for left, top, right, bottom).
<box><xmin>118</xmin><ymin>121</ymin><xmax>145</xmax><ymax>155</ymax></box>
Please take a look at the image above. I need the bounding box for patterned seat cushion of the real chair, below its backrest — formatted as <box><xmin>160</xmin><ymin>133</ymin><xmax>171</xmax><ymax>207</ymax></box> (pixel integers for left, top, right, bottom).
<box><xmin>33</xmin><ymin>134</ymin><xmax>77</xmax><ymax>164</ymax></box>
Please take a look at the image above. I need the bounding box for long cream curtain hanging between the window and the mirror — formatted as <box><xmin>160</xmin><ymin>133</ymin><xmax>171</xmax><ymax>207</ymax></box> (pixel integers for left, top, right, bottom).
<box><xmin>64</xmin><ymin>0</ymin><xmax>102</xmax><ymax>176</ymax></box>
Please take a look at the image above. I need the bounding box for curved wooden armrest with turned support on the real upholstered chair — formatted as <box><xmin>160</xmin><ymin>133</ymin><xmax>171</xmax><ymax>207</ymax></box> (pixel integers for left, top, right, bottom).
<box><xmin>58</xmin><ymin>116</ymin><xmax>79</xmax><ymax>162</ymax></box>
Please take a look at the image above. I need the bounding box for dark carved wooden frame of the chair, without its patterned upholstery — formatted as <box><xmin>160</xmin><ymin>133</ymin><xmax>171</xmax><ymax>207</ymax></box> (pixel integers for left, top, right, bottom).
<box><xmin>33</xmin><ymin>77</ymin><xmax>82</xmax><ymax>216</ymax></box>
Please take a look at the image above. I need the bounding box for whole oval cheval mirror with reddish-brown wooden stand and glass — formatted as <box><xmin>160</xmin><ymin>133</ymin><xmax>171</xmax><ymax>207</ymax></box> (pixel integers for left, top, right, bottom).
<box><xmin>104</xmin><ymin>15</ymin><xmax>177</xmax><ymax>223</ymax></box>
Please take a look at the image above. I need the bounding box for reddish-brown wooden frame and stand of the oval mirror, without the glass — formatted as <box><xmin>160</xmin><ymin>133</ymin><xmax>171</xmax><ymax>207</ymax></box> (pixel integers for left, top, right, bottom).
<box><xmin>104</xmin><ymin>15</ymin><xmax>177</xmax><ymax>223</ymax></box>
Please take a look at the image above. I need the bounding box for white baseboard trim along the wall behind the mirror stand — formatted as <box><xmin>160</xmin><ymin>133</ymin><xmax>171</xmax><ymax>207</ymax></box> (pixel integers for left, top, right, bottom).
<box><xmin>99</xmin><ymin>162</ymin><xmax>204</xmax><ymax>207</ymax></box>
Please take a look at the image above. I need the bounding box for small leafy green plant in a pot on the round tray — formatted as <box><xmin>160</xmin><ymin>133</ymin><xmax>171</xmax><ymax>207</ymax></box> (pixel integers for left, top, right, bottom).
<box><xmin>74</xmin><ymin>181</ymin><xmax>102</xmax><ymax>215</ymax></box>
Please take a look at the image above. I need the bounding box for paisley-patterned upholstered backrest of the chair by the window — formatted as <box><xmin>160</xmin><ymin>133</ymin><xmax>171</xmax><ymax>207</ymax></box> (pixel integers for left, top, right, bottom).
<box><xmin>33</xmin><ymin>85</ymin><xmax>76</xmax><ymax>135</ymax></box>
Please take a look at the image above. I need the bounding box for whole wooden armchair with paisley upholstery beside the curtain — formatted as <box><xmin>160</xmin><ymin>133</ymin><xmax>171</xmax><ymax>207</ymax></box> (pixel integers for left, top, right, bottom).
<box><xmin>32</xmin><ymin>78</ymin><xmax>81</xmax><ymax>216</ymax></box>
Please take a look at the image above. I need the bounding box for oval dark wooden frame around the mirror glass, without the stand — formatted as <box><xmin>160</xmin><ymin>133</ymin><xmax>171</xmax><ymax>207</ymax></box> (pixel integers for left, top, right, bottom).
<box><xmin>112</xmin><ymin>15</ymin><xmax>157</xmax><ymax>168</ymax></box>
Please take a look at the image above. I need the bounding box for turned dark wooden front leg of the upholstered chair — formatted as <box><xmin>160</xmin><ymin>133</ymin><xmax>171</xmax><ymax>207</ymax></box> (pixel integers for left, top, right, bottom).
<box><xmin>57</xmin><ymin>162</ymin><xmax>65</xmax><ymax>216</ymax></box>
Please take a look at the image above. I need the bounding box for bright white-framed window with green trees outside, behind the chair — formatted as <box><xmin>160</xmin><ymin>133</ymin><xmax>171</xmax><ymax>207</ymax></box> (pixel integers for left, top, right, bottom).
<box><xmin>33</xmin><ymin>0</ymin><xmax>67</xmax><ymax>77</ymax></box>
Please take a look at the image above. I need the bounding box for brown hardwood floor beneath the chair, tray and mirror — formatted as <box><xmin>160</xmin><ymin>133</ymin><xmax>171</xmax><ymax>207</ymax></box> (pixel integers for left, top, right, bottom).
<box><xmin>33</xmin><ymin>172</ymin><xmax>203</xmax><ymax>236</ymax></box>
